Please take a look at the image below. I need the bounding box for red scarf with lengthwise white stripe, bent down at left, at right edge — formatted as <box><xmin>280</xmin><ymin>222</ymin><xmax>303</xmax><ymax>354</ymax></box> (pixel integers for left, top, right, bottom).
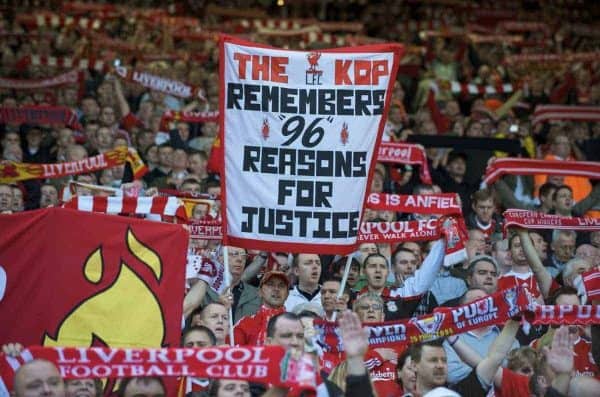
<box><xmin>481</xmin><ymin>157</ymin><xmax>600</xmax><ymax>188</ymax></box>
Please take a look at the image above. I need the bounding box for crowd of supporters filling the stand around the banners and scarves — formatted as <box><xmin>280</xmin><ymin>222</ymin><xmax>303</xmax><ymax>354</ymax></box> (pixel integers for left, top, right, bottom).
<box><xmin>0</xmin><ymin>0</ymin><xmax>600</xmax><ymax>397</ymax></box>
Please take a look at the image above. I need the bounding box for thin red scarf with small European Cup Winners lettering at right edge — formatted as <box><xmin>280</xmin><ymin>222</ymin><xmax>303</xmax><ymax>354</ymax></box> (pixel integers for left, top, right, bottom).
<box><xmin>503</xmin><ymin>209</ymin><xmax>600</xmax><ymax>232</ymax></box>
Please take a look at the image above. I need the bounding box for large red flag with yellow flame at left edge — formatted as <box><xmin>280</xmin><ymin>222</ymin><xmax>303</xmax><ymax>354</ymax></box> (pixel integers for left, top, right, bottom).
<box><xmin>0</xmin><ymin>208</ymin><xmax>188</xmax><ymax>348</ymax></box>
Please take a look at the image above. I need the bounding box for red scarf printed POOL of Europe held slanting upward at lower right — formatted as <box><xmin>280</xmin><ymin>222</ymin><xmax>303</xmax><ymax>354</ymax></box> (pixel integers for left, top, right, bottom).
<box><xmin>315</xmin><ymin>287</ymin><xmax>530</xmax><ymax>353</ymax></box>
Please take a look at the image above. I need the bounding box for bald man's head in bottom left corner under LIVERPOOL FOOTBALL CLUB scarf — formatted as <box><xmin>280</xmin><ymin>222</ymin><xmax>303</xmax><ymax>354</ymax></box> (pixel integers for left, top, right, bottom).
<box><xmin>15</xmin><ymin>361</ymin><xmax>65</xmax><ymax>397</ymax></box>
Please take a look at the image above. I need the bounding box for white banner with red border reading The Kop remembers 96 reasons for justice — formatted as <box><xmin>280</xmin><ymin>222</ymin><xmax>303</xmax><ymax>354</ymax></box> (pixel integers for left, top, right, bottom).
<box><xmin>219</xmin><ymin>36</ymin><xmax>403</xmax><ymax>254</ymax></box>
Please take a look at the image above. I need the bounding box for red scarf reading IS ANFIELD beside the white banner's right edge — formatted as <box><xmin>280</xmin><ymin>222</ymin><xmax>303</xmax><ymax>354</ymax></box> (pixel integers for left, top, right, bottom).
<box><xmin>367</xmin><ymin>193</ymin><xmax>462</xmax><ymax>215</ymax></box>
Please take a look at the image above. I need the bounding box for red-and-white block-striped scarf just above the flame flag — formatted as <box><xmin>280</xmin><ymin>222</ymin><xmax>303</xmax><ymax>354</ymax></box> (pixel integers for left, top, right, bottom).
<box><xmin>63</xmin><ymin>196</ymin><xmax>188</xmax><ymax>222</ymax></box>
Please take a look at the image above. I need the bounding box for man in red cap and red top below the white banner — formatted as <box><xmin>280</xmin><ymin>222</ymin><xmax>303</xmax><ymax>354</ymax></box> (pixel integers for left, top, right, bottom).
<box><xmin>233</xmin><ymin>271</ymin><xmax>290</xmax><ymax>346</ymax></box>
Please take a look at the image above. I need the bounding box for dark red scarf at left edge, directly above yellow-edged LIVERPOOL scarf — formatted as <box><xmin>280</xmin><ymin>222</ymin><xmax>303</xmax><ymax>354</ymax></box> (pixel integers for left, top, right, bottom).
<box><xmin>0</xmin><ymin>105</ymin><xmax>83</xmax><ymax>131</ymax></box>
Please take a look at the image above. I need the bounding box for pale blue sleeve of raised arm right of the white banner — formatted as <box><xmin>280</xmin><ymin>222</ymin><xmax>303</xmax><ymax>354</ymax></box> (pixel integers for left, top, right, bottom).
<box><xmin>391</xmin><ymin>239</ymin><xmax>446</xmax><ymax>298</ymax></box>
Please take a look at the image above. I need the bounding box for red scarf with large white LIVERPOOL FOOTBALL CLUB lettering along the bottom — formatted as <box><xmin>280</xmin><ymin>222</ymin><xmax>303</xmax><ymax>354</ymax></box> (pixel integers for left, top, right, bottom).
<box><xmin>0</xmin><ymin>346</ymin><xmax>317</xmax><ymax>391</ymax></box>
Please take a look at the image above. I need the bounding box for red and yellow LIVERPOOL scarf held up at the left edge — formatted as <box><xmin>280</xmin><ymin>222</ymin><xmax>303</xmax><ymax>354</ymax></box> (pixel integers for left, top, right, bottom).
<box><xmin>0</xmin><ymin>146</ymin><xmax>147</xmax><ymax>183</ymax></box>
